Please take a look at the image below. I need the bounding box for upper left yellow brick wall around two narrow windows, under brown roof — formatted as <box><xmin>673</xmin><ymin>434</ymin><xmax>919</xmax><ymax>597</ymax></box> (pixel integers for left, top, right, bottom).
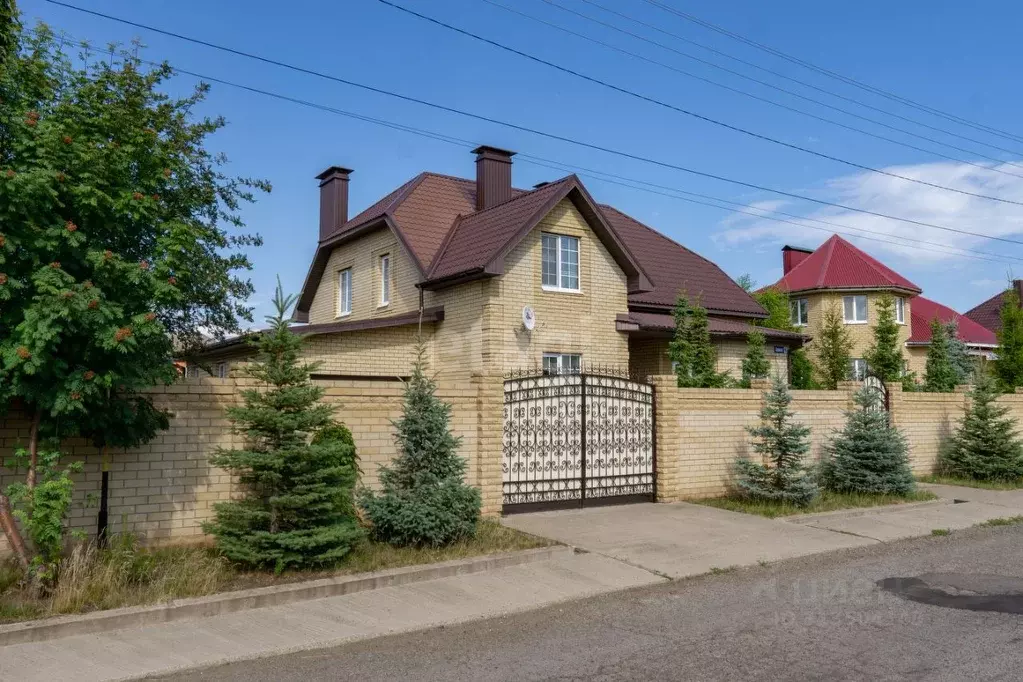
<box><xmin>309</xmin><ymin>227</ymin><xmax>419</xmax><ymax>324</ymax></box>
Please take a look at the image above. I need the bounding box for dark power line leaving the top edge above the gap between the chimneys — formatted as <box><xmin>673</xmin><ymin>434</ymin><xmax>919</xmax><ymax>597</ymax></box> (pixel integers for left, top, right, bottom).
<box><xmin>376</xmin><ymin>0</ymin><xmax>1023</xmax><ymax>206</ymax></box>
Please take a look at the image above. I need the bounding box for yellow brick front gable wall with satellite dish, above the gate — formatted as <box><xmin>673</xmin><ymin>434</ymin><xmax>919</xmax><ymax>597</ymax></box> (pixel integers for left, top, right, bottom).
<box><xmin>482</xmin><ymin>199</ymin><xmax>629</xmax><ymax>371</ymax></box>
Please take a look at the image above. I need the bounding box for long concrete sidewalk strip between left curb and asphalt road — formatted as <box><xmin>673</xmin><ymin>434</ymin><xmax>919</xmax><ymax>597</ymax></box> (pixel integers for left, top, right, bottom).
<box><xmin>0</xmin><ymin>553</ymin><xmax>664</xmax><ymax>682</ymax></box>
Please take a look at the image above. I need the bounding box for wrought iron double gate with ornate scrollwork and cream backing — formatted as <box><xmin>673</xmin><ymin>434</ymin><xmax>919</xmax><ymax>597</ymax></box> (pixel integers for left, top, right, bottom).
<box><xmin>501</xmin><ymin>373</ymin><xmax>656</xmax><ymax>512</ymax></box>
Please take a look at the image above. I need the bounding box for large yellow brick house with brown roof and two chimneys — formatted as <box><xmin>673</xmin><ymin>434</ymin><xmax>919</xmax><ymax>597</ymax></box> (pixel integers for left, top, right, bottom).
<box><xmin>201</xmin><ymin>146</ymin><xmax>803</xmax><ymax>378</ymax></box>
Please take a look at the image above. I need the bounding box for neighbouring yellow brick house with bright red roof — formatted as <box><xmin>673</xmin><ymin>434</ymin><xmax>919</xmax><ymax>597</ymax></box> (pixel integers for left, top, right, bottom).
<box><xmin>770</xmin><ymin>234</ymin><xmax>995</xmax><ymax>378</ymax></box>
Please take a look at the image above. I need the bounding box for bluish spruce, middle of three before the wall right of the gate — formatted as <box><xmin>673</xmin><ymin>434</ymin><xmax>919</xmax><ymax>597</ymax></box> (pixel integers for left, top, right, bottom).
<box><xmin>820</xmin><ymin>387</ymin><xmax>916</xmax><ymax>495</ymax></box>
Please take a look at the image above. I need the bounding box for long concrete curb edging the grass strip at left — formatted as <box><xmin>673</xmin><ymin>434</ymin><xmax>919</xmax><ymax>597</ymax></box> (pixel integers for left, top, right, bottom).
<box><xmin>0</xmin><ymin>545</ymin><xmax>574</xmax><ymax>646</ymax></box>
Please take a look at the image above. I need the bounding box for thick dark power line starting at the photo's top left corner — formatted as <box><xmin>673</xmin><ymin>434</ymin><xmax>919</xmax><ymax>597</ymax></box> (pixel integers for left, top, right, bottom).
<box><xmin>39</xmin><ymin>0</ymin><xmax>1023</xmax><ymax>245</ymax></box>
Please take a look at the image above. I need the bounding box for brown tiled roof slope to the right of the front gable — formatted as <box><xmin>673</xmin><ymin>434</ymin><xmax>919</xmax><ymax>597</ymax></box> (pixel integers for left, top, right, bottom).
<box><xmin>601</xmin><ymin>204</ymin><xmax>766</xmax><ymax>317</ymax></box>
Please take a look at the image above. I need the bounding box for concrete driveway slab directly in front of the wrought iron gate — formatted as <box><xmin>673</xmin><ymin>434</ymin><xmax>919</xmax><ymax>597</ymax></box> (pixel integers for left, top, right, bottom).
<box><xmin>501</xmin><ymin>502</ymin><xmax>875</xmax><ymax>578</ymax></box>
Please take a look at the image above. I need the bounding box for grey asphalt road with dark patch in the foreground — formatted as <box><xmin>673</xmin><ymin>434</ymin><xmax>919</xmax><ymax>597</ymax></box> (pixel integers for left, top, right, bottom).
<box><xmin>162</xmin><ymin>526</ymin><xmax>1023</xmax><ymax>682</ymax></box>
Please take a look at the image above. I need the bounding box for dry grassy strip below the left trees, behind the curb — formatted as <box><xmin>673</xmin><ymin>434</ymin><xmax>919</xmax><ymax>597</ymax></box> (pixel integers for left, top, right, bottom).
<box><xmin>0</xmin><ymin>520</ymin><xmax>552</xmax><ymax>623</ymax></box>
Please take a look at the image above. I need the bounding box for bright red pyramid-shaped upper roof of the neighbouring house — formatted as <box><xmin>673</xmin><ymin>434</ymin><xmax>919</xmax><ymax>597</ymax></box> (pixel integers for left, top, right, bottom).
<box><xmin>773</xmin><ymin>234</ymin><xmax>921</xmax><ymax>293</ymax></box>
